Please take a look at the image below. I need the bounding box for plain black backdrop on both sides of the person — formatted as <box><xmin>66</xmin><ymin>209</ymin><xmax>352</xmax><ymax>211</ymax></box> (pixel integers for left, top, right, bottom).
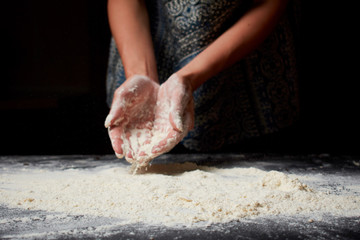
<box><xmin>0</xmin><ymin>0</ymin><xmax>360</xmax><ymax>155</ymax></box>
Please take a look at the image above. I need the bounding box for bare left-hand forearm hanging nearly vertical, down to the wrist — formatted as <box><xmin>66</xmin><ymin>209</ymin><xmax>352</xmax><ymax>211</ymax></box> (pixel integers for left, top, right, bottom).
<box><xmin>108</xmin><ymin>0</ymin><xmax>158</xmax><ymax>81</ymax></box>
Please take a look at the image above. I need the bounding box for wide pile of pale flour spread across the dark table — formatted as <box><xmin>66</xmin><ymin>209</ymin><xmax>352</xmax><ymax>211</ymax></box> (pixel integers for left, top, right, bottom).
<box><xmin>0</xmin><ymin>163</ymin><xmax>360</xmax><ymax>227</ymax></box>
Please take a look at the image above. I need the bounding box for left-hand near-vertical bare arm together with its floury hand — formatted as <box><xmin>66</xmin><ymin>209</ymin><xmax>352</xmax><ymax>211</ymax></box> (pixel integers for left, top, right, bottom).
<box><xmin>105</xmin><ymin>0</ymin><xmax>159</xmax><ymax>159</ymax></box>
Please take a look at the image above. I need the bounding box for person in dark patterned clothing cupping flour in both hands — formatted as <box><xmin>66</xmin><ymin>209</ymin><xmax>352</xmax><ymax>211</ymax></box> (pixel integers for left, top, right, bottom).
<box><xmin>105</xmin><ymin>0</ymin><xmax>298</xmax><ymax>165</ymax></box>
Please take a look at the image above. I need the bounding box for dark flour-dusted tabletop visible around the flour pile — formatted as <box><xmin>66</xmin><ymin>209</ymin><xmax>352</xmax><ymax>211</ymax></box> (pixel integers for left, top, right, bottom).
<box><xmin>0</xmin><ymin>154</ymin><xmax>360</xmax><ymax>240</ymax></box>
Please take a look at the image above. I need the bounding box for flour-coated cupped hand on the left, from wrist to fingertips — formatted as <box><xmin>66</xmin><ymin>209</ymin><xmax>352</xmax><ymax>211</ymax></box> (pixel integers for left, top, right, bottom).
<box><xmin>105</xmin><ymin>75</ymin><xmax>159</xmax><ymax>162</ymax></box>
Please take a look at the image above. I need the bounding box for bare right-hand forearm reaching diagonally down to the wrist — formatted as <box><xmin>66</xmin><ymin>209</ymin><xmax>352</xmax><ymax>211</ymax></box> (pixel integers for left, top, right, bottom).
<box><xmin>177</xmin><ymin>0</ymin><xmax>287</xmax><ymax>90</ymax></box>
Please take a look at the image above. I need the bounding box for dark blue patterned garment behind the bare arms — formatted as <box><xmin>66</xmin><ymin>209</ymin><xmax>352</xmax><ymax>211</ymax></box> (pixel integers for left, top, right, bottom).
<box><xmin>107</xmin><ymin>0</ymin><xmax>299</xmax><ymax>151</ymax></box>
